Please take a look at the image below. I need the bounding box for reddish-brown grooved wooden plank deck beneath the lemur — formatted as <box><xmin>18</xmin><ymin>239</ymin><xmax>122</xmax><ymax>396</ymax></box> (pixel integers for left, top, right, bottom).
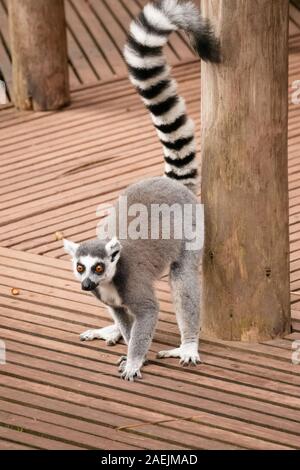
<box><xmin>0</xmin><ymin>0</ymin><xmax>300</xmax><ymax>450</ymax></box>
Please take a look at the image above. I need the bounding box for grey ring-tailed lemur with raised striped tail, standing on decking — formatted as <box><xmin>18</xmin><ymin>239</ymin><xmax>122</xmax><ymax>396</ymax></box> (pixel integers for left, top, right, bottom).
<box><xmin>64</xmin><ymin>0</ymin><xmax>219</xmax><ymax>380</ymax></box>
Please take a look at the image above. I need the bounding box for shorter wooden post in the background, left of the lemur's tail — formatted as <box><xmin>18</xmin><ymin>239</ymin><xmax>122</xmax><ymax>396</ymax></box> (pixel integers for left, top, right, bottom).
<box><xmin>8</xmin><ymin>0</ymin><xmax>70</xmax><ymax>111</ymax></box>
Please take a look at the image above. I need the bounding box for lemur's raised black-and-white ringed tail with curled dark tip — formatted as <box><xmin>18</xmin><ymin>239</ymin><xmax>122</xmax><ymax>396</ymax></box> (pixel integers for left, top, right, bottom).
<box><xmin>124</xmin><ymin>0</ymin><xmax>219</xmax><ymax>190</ymax></box>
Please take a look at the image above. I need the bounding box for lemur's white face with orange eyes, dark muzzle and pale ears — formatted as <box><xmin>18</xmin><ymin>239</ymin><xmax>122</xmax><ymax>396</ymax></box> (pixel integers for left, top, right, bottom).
<box><xmin>64</xmin><ymin>238</ymin><xmax>121</xmax><ymax>291</ymax></box>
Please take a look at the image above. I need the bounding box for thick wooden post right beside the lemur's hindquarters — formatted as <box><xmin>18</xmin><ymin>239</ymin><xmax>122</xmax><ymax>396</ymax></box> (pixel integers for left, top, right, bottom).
<box><xmin>201</xmin><ymin>0</ymin><xmax>291</xmax><ymax>341</ymax></box>
